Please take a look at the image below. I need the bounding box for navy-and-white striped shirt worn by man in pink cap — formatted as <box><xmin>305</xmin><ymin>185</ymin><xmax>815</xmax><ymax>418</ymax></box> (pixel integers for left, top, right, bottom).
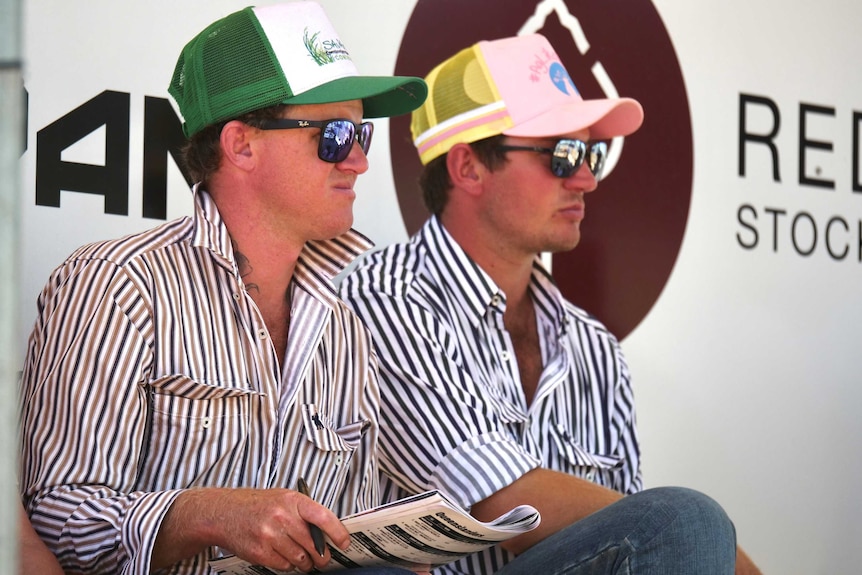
<box><xmin>340</xmin><ymin>218</ymin><xmax>642</xmax><ymax>574</ymax></box>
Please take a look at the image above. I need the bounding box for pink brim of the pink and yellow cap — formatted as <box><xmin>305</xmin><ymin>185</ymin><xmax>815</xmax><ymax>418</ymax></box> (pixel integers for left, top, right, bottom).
<box><xmin>503</xmin><ymin>98</ymin><xmax>644</xmax><ymax>140</ymax></box>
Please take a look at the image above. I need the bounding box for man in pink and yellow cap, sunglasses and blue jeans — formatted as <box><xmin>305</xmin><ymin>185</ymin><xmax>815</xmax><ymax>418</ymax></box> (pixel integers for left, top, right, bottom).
<box><xmin>340</xmin><ymin>35</ymin><xmax>760</xmax><ymax>575</ymax></box>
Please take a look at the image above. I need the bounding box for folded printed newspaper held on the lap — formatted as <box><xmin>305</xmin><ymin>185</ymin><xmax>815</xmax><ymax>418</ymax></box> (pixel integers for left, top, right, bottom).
<box><xmin>210</xmin><ymin>491</ymin><xmax>541</xmax><ymax>575</ymax></box>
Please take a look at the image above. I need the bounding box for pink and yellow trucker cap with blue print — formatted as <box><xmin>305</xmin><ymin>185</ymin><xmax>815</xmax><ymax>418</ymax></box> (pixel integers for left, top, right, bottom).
<box><xmin>410</xmin><ymin>34</ymin><xmax>643</xmax><ymax>164</ymax></box>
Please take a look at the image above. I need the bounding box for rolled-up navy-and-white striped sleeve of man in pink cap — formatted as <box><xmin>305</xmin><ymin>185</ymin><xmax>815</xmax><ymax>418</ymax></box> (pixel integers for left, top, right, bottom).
<box><xmin>342</xmin><ymin>282</ymin><xmax>539</xmax><ymax>507</ymax></box>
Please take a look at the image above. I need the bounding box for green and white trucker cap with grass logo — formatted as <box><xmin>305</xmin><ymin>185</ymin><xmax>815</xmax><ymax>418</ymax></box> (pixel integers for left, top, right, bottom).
<box><xmin>168</xmin><ymin>2</ymin><xmax>428</xmax><ymax>136</ymax></box>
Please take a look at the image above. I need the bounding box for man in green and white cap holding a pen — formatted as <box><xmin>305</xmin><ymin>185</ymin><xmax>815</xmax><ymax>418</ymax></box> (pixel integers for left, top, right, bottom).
<box><xmin>16</xmin><ymin>2</ymin><xmax>426</xmax><ymax>574</ymax></box>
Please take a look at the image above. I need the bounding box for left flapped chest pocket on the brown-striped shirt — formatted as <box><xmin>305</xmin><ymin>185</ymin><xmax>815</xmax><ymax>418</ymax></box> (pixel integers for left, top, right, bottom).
<box><xmin>140</xmin><ymin>375</ymin><xmax>262</xmax><ymax>490</ymax></box>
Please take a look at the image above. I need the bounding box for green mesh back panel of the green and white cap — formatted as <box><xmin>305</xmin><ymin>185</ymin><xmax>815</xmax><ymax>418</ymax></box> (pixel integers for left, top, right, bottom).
<box><xmin>168</xmin><ymin>8</ymin><xmax>292</xmax><ymax>136</ymax></box>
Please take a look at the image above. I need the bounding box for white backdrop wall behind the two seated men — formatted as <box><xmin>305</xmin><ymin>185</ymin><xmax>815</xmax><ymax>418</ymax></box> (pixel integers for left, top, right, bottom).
<box><xmin>19</xmin><ymin>0</ymin><xmax>862</xmax><ymax>575</ymax></box>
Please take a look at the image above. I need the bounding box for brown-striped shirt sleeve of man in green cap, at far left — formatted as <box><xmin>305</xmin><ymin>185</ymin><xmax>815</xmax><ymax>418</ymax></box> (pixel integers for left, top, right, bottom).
<box><xmin>20</xmin><ymin>261</ymin><xmax>179</xmax><ymax>573</ymax></box>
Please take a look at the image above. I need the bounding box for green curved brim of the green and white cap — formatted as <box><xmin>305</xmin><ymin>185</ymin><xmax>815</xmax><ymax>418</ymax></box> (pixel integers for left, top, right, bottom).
<box><xmin>283</xmin><ymin>76</ymin><xmax>428</xmax><ymax>118</ymax></box>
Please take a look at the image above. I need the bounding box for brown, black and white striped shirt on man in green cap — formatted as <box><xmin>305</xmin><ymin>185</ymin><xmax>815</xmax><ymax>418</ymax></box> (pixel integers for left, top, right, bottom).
<box><xmin>20</xmin><ymin>190</ymin><xmax>380</xmax><ymax>574</ymax></box>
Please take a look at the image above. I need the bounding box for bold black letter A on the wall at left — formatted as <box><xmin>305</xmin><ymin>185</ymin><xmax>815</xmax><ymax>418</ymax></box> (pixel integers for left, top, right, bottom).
<box><xmin>36</xmin><ymin>90</ymin><xmax>129</xmax><ymax>216</ymax></box>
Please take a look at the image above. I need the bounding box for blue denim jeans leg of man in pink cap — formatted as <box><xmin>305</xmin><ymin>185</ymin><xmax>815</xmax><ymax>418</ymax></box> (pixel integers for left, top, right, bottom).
<box><xmin>497</xmin><ymin>487</ymin><xmax>736</xmax><ymax>575</ymax></box>
